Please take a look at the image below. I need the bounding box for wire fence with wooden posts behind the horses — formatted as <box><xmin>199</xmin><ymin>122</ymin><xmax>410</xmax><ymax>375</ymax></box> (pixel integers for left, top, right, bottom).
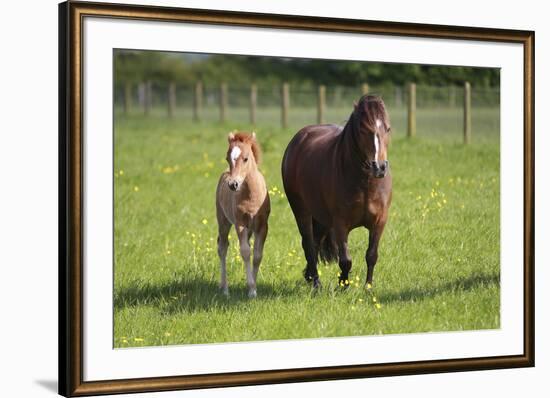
<box><xmin>114</xmin><ymin>81</ymin><xmax>500</xmax><ymax>142</ymax></box>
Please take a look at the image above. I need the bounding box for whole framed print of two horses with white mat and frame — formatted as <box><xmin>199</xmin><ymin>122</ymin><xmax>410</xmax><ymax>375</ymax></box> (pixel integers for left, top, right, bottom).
<box><xmin>59</xmin><ymin>1</ymin><xmax>534</xmax><ymax>396</ymax></box>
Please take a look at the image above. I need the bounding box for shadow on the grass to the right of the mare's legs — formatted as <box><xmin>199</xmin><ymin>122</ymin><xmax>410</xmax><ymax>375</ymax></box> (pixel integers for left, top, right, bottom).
<box><xmin>378</xmin><ymin>274</ymin><xmax>500</xmax><ymax>304</ymax></box>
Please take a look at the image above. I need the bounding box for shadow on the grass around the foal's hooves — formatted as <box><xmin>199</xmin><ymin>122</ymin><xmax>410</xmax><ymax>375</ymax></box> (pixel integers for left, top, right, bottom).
<box><xmin>114</xmin><ymin>278</ymin><xmax>310</xmax><ymax>314</ymax></box>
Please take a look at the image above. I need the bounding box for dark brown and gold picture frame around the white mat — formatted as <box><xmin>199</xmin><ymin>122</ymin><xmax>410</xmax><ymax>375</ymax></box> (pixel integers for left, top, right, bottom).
<box><xmin>59</xmin><ymin>1</ymin><xmax>535</xmax><ymax>397</ymax></box>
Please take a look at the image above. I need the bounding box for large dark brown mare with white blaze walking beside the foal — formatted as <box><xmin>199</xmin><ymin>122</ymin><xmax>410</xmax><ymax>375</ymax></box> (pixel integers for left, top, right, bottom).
<box><xmin>282</xmin><ymin>95</ymin><xmax>392</xmax><ymax>287</ymax></box>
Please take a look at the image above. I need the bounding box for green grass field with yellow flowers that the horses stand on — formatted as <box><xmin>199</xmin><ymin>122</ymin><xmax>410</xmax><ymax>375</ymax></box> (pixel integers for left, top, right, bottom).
<box><xmin>114</xmin><ymin>110</ymin><xmax>500</xmax><ymax>347</ymax></box>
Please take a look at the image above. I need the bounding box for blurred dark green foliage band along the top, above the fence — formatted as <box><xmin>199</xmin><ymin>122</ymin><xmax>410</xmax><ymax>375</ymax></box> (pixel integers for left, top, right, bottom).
<box><xmin>115</xmin><ymin>50</ymin><xmax>500</xmax><ymax>87</ymax></box>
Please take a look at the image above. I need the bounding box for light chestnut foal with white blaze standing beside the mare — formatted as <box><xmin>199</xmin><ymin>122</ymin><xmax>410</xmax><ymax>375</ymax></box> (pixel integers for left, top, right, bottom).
<box><xmin>216</xmin><ymin>133</ymin><xmax>271</xmax><ymax>298</ymax></box>
